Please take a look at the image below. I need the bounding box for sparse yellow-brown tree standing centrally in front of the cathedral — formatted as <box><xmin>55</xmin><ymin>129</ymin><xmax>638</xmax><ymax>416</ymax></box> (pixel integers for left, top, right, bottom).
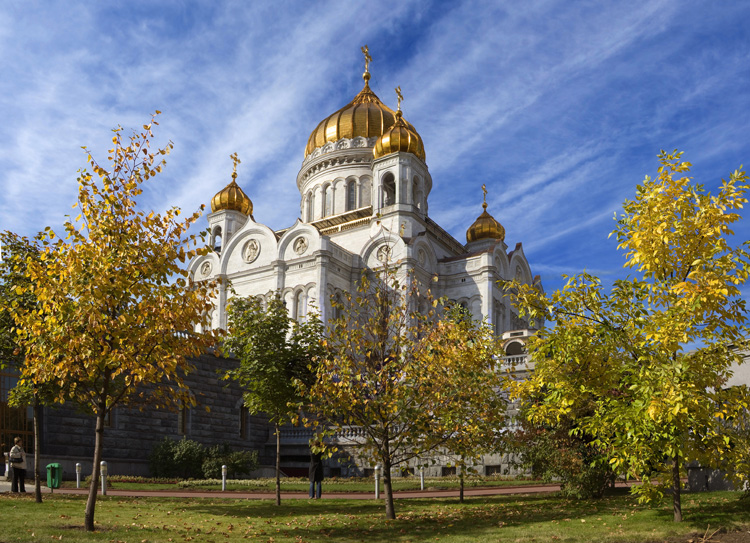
<box><xmin>305</xmin><ymin>265</ymin><xmax>501</xmax><ymax>519</ymax></box>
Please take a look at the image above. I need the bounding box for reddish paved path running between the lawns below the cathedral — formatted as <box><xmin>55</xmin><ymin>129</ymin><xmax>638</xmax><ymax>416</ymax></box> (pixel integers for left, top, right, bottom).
<box><xmin>0</xmin><ymin>480</ymin><xmax>629</xmax><ymax>500</ymax></box>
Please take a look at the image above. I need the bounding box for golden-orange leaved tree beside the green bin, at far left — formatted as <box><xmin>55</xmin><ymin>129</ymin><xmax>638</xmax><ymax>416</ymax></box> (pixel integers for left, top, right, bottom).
<box><xmin>15</xmin><ymin>112</ymin><xmax>214</xmax><ymax>531</ymax></box>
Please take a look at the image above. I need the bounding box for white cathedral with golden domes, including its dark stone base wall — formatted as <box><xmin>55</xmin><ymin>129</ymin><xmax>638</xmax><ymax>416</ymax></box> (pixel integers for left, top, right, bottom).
<box><xmin>14</xmin><ymin>49</ymin><xmax>541</xmax><ymax>478</ymax></box>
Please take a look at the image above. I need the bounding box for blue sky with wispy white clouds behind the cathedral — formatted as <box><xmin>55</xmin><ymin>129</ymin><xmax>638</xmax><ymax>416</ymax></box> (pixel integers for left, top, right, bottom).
<box><xmin>0</xmin><ymin>0</ymin><xmax>750</xmax><ymax>299</ymax></box>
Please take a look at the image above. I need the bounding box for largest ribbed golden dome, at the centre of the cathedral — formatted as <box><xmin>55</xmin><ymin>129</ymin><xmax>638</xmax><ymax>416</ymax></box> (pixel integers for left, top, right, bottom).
<box><xmin>305</xmin><ymin>72</ymin><xmax>424</xmax><ymax>157</ymax></box>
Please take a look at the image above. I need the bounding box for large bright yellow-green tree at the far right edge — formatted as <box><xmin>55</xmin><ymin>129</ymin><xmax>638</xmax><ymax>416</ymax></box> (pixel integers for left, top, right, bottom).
<box><xmin>510</xmin><ymin>151</ymin><xmax>750</xmax><ymax>521</ymax></box>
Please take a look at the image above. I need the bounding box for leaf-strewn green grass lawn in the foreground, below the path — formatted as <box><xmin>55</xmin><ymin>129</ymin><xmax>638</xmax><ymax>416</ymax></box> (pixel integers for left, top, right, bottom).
<box><xmin>0</xmin><ymin>491</ymin><xmax>750</xmax><ymax>543</ymax></box>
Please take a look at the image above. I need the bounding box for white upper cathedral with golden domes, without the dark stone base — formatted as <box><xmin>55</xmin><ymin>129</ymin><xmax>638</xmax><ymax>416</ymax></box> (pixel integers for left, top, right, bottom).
<box><xmin>189</xmin><ymin>52</ymin><xmax>541</xmax><ymax>335</ymax></box>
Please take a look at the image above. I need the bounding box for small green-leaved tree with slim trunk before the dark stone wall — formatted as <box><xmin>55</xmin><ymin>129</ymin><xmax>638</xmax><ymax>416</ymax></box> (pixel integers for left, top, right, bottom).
<box><xmin>224</xmin><ymin>293</ymin><xmax>322</xmax><ymax>505</ymax></box>
